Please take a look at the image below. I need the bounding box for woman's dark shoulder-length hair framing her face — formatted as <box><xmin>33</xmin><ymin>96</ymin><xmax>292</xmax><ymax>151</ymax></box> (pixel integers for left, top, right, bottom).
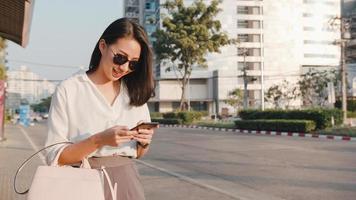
<box><xmin>87</xmin><ymin>18</ymin><xmax>154</xmax><ymax>106</ymax></box>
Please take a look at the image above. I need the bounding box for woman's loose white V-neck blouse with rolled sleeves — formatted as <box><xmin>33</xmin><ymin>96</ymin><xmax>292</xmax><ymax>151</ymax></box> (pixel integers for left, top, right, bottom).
<box><xmin>46</xmin><ymin>73</ymin><xmax>151</xmax><ymax>165</ymax></box>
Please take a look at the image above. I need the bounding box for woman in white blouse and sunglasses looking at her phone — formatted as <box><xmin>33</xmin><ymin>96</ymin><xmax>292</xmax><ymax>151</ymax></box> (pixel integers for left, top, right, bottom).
<box><xmin>46</xmin><ymin>18</ymin><xmax>154</xmax><ymax>200</ymax></box>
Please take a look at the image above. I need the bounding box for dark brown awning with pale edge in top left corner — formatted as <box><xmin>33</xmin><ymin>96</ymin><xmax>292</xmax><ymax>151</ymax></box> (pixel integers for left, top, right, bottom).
<box><xmin>0</xmin><ymin>0</ymin><xmax>35</xmax><ymax>47</ymax></box>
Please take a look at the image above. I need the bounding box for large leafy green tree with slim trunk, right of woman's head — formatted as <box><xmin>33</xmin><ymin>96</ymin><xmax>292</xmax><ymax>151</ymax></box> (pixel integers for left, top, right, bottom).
<box><xmin>153</xmin><ymin>0</ymin><xmax>235</xmax><ymax>110</ymax></box>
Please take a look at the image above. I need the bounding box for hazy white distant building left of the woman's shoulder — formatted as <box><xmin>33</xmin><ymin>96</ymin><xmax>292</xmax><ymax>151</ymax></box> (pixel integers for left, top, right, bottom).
<box><xmin>6</xmin><ymin>66</ymin><xmax>56</xmax><ymax>108</ymax></box>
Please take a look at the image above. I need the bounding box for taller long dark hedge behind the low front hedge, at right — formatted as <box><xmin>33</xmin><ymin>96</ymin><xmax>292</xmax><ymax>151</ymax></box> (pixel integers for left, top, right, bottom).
<box><xmin>239</xmin><ymin>109</ymin><xmax>343</xmax><ymax>129</ymax></box>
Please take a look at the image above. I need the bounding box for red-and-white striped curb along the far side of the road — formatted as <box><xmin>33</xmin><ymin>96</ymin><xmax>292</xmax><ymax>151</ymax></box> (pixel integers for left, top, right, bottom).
<box><xmin>160</xmin><ymin>124</ymin><xmax>356</xmax><ymax>141</ymax></box>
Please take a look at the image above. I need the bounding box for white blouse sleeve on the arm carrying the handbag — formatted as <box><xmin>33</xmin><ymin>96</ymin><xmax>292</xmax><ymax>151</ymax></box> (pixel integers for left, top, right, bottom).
<box><xmin>45</xmin><ymin>85</ymin><xmax>69</xmax><ymax>166</ymax></box>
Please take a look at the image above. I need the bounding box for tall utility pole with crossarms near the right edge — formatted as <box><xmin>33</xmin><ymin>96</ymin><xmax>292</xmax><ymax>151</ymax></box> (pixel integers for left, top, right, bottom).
<box><xmin>330</xmin><ymin>17</ymin><xmax>351</xmax><ymax>124</ymax></box>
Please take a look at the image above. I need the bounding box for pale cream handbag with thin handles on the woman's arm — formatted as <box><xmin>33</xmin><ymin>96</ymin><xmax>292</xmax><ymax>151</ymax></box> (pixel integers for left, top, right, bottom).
<box><xmin>14</xmin><ymin>142</ymin><xmax>117</xmax><ymax>200</ymax></box>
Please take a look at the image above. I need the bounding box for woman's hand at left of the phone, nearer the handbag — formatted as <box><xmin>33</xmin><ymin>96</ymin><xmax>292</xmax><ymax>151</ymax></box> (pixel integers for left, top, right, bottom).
<box><xmin>96</xmin><ymin>126</ymin><xmax>137</xmax><ymax>147</ymax></box>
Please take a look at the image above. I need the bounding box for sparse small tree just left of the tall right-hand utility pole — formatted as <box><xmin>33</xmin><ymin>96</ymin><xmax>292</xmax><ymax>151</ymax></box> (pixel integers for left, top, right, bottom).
<box><xmin>298</xmin><ymin>69</ymin><xmax>338</xmax><ymax>106</ymax></box>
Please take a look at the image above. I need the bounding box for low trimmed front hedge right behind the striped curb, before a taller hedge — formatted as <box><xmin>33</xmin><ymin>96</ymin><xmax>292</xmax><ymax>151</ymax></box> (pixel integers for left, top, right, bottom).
<box><xmin>235</xmin><ymin>119</ymin><xmax>316</xmax><ymax>132</ymax></box>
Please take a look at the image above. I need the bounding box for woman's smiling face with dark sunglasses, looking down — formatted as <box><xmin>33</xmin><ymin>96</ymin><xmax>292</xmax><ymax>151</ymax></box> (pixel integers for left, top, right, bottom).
<box><xmin>99</xmin><ymin>38</ymin><xmax>141</xmax><ymax>81</ymax></box>
